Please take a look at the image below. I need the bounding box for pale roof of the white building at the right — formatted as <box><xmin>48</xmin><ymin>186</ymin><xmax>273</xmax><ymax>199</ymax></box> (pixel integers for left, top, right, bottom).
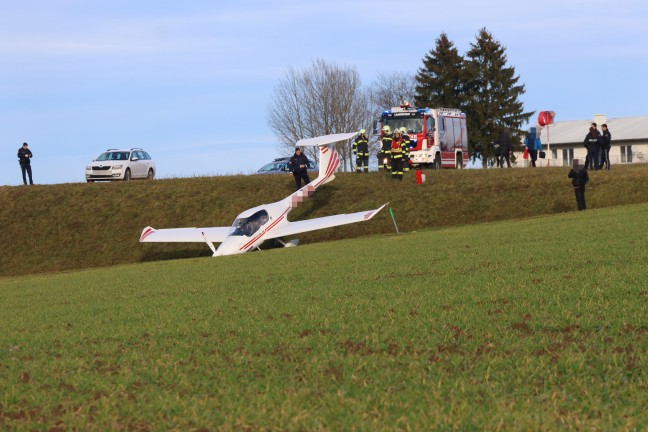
<box><xmin>540</xmin><ymin>116</ymin><xmax>648</xmax><ymax>144</ymax></box>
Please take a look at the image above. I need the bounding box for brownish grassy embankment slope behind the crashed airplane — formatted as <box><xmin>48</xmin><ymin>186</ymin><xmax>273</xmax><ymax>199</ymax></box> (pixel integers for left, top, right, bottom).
<box><xmin>0</xmin><ymin>165</ymin><xmax>648</xmax><ymax>276</ymax></box>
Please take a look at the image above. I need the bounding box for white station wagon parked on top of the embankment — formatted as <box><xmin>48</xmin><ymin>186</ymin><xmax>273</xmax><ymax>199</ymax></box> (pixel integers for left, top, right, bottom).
<box><xmin>86</xmin><ymin>148</ymin><xmax>155</xmax><ymax>183</ymax></box>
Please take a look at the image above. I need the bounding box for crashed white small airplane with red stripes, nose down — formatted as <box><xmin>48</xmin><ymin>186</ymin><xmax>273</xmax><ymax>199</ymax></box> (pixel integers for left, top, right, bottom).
<box><xmin>140</xmin><ymin>133</ymin><xmax>387</xmax><ymax>256</ymax></box>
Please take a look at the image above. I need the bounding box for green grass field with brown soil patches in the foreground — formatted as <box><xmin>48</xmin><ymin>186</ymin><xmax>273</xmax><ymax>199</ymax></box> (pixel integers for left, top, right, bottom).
<box><xmin>0</xmin><ymin>204</ymin><xmax>648</xmax><ymax>431</ymax></box>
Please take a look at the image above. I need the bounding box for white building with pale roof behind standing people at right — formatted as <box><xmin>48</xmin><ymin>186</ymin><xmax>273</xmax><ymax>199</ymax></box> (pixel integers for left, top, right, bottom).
<box><xmin>536</xmin><ymin>114</ymin><xmax>648</xmax><ymax>166</ymax></box>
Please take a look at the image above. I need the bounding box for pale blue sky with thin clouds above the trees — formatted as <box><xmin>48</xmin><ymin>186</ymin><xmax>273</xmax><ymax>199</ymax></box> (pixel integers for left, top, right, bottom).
<box><xmin>0</xmin><ymin>0</ymin><xmax>648</xmax><ymax>185</ymax></box>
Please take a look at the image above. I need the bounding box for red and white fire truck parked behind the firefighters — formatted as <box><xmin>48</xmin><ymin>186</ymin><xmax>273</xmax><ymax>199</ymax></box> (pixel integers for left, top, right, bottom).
<box><xmin>377</xmin><ymin>105</ymin><xmax>469</xmax><ymax>169</ymax></box>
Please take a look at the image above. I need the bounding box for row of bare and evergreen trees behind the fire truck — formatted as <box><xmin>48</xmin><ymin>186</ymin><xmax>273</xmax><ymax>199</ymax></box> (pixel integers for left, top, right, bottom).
<box><xmin>267</xmin><ymin>28</ymin><xmax>533</xmax><ymax>171</ymax></box>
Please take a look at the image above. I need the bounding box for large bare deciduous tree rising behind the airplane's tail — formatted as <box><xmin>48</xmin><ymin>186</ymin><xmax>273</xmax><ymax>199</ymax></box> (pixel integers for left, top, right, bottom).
<box><xmin>267</xmin><ymin>59</ymin><xmax>372</xmax><ymax>171</ymax></box>
